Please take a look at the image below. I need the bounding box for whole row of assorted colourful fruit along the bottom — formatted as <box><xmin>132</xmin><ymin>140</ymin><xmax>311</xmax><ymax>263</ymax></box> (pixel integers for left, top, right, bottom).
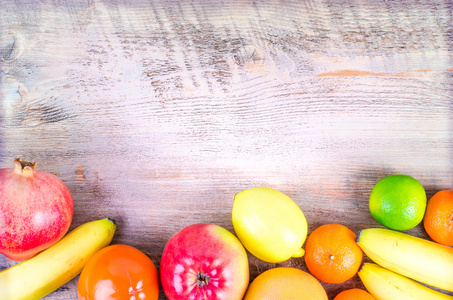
<box><xmin>0</xmin><ymin>159</ymin><xmax>453</xmax><ymax>300</ymax></box>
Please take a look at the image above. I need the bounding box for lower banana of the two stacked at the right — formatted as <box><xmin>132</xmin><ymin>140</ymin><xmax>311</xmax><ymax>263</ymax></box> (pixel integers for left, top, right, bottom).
<box><xmin>358</xmin><ymin>263</ymin><xmax>453</xmax><ymax>300</ymax></box>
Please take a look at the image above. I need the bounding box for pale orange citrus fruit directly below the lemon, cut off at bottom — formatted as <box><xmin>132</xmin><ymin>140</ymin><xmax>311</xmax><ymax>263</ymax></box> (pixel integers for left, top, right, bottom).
<box><xmin>244</xmin><ymin>267</ymin><xmax>328</xmax><ymax>300</ymax></box>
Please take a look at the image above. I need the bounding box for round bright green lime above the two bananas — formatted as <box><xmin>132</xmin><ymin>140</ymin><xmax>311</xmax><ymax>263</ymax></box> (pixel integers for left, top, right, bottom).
<box><xmin>369</xmin><ymin>174</ymin><xmax>426</xmax><ymax>230</ymax></box>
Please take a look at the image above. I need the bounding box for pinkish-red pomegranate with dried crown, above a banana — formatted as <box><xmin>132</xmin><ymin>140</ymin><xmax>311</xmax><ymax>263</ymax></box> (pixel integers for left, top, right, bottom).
<box><xmin>0</xmin><ymin>159</ymin><xmax>73</xmax><ymax>261</ymax></box>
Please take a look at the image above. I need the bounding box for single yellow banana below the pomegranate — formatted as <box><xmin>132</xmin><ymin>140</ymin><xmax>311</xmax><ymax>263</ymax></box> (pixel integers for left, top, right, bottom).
<box><xmin>0</xmin><ymin>219</ymin><xmax>116</xmax><ymax>300</ymax></box>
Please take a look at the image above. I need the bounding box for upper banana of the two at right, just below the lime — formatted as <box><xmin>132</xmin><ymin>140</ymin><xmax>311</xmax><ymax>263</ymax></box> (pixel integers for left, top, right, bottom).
<box><xmin>357</xmin><ymin>228</ymin><xmax>453</xmax><ymax>292</ymax></box>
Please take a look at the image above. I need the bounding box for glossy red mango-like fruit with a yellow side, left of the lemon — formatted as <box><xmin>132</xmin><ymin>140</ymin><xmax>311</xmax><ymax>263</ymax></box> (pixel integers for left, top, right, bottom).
<box><xmin>159</xmin><ymin>223</ymin><xmax>249</xmax><ymax>300</ymax></box>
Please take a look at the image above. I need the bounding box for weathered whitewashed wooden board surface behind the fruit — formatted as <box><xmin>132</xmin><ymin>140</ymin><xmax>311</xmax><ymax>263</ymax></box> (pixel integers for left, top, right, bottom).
<box><xmin>0</xmin><ymin>0</ymin><xmax>453</xmax><ymax>300</ymax></box>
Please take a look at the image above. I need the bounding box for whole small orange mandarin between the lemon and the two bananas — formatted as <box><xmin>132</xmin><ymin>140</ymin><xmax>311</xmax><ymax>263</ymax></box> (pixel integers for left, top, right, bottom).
<box><xmin>305</xmin><ymin>224</ymin><xmax>363</xmax><ymax>283</ymax></box>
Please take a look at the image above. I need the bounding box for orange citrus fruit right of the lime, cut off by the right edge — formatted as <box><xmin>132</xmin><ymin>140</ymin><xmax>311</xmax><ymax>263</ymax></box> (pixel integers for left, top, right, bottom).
<box><xmin>423</xmin><ymin>190</ymin><xmax>453</xmax><ymax>246</ymax></box>
